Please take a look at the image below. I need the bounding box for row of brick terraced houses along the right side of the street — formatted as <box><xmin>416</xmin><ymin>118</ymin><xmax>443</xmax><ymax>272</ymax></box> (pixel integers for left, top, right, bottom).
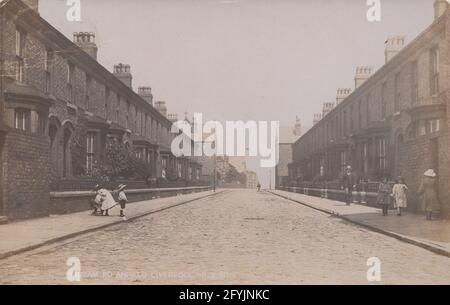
<box><xmin>289</xmin><ymin>0</ymin><xmax>450</xmax><ymax>214</ymax></box>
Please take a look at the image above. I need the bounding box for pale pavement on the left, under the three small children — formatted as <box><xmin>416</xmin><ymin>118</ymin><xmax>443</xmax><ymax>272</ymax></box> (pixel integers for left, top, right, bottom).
<box><xmin>0</xmin><ymin>191</ymin><xmax>219</xmax><ymax>259</ymax></box>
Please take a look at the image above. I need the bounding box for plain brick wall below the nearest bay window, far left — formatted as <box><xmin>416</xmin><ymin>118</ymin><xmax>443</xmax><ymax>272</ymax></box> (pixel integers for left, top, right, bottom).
<box><xmin>2</xmin><ymin>131</ymin><xmax>50</xmax><ymax>219</ymax></box>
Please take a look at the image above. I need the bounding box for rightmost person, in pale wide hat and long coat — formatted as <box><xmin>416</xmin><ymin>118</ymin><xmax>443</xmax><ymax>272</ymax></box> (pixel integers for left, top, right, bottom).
<box><xmin>418</xmin><ymin>169</ymin><xmax>440</xmax><ymax>220</ymax></box>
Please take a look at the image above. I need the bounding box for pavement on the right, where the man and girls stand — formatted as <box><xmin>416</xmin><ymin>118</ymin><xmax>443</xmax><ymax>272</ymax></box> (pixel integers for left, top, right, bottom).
<box><xmin>270</xmin><ymin>190</ymin><xmax>450</xmax><ymax>257</ymax></box>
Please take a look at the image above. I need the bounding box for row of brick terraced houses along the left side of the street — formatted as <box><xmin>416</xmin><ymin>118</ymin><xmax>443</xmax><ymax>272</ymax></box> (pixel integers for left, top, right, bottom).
<box><xmin>0</xmin><ymin>0</ymin><xmax>201</xmax><ymax>219</ymax></box>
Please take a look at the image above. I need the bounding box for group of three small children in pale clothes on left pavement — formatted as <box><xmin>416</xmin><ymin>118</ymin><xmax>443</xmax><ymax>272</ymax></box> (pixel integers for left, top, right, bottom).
<box><xmin>92</xmin><ymin>184</ymin><xmax>128</xmax><ymax>219</ymax></box>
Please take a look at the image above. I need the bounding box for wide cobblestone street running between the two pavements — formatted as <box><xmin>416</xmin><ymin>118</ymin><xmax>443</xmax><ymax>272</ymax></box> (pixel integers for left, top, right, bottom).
<box><xmin>0</xmin><ymin>190</ymin><xmax>450</xmax><ymax>284</ymax></box>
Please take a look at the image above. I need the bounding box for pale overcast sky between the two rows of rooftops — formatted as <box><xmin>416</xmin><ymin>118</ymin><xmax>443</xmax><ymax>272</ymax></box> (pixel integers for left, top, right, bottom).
<box><xmin>41</xmin><ymin>0</ymin><xmax>433</xmax><ymax>186</ymax></box>
